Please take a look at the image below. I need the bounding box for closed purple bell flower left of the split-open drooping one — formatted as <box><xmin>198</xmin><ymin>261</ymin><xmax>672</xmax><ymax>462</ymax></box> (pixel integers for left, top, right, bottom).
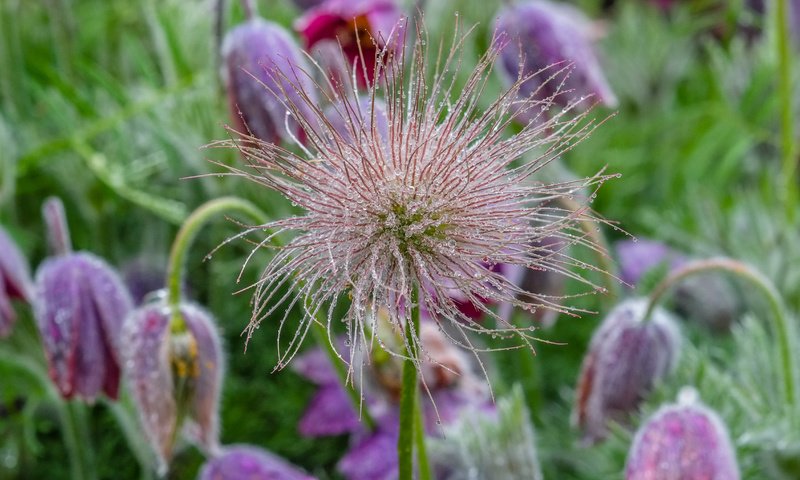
<box><xmin>34</xmin><ymin>252</ymin><xmax>133</xmax><ymax>401</ymax></box>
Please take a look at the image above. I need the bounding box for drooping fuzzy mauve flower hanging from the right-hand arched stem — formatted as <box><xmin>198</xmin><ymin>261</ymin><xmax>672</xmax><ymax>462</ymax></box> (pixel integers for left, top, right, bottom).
<box><xmin>574</xmin><ymin>298</ymin><xmax>680</xmax><ymax>441</ymax></box>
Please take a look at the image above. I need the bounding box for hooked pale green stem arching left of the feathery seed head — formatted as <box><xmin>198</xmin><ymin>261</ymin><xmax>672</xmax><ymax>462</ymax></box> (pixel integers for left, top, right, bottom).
<box><xmin>166</xmin><ymin>197</ymin><xmax>267</xmax><ymax>332</ymax></box>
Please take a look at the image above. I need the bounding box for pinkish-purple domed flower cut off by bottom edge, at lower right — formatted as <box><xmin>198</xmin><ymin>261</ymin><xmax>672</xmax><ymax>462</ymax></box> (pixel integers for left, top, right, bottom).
<box><xmin>625</xmin><ymin>390</ymin><xmax>739</xmax><ymax>480</ymax></box>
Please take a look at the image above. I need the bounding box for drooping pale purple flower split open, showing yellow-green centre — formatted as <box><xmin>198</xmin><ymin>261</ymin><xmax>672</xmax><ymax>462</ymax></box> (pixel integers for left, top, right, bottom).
<box><xmin>122</xmin><ymin>302</ymin><xmax>224</xmax><ymax>470</ymax></box>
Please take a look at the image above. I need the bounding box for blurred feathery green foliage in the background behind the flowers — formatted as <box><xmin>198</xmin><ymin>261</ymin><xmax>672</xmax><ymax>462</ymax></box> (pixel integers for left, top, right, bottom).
<box><xmin>0</xmin><ymin>0</ymin><xmax>800</xmax><ymax>479</ymax></box>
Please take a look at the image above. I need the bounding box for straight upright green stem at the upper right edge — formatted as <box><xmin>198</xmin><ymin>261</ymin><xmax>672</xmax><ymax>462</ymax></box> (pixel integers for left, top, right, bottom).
<box><xmin>774</xmin><ymin>0</ymin><xmax>797</xmax><ymax>222</ymax></box>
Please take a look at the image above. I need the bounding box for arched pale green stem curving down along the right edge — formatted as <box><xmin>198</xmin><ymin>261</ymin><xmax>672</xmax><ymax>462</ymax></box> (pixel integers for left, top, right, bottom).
<box><xmin>644</xmin><ymin>258</ymin><xmax>797</xmax><ymax>406</ymax></box>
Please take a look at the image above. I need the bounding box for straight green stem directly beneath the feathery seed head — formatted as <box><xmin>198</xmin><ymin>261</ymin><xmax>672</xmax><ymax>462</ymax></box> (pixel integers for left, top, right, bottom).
<box><xmin>397</xmin><ymin>289</ymin><xmax>427</xmax><ymax>480</ymax></box>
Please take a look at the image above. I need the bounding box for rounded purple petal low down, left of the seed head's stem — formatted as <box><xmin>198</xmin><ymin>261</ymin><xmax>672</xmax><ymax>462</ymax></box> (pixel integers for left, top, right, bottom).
<box><xmin>298</xmin><ymin>384</ymin><xmax>361</xmax><ymax>437</ymax></box>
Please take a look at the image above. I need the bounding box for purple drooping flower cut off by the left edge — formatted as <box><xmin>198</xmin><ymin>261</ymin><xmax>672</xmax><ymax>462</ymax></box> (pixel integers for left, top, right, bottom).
<box><xmin>0</xmin><ymin>227</ymin><xmax>33</xmax><ymax>338</ymax></box>
